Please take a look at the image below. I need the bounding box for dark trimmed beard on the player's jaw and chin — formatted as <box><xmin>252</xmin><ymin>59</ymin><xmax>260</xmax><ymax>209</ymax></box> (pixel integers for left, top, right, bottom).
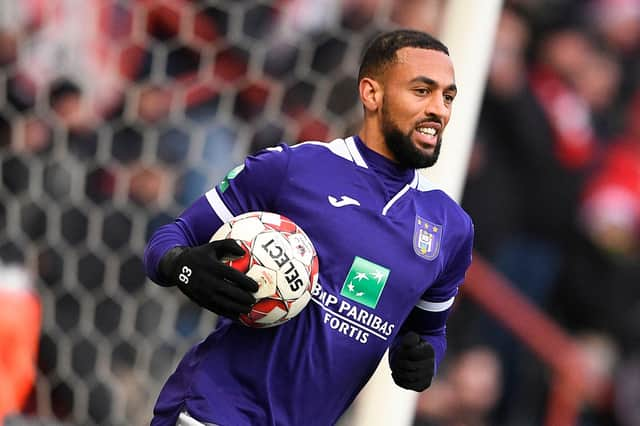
<box><xmin>381</xmin><ymin>105</ymin><xmax>442</xmax><ymax>169</ymax></box>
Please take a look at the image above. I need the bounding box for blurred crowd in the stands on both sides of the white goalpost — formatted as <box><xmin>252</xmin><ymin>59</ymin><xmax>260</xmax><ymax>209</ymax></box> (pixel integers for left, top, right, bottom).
<box><xmin>0</xmin><ymin>0</ymin><xmax>640</xmax><ymax>426</ymax></box>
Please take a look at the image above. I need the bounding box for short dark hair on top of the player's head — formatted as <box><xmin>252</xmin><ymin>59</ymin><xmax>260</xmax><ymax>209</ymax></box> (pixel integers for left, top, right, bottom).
<box><xmin>358</xmin><ymin>30</ymin><xmax>449</xmax><ymax>81</ymax></box>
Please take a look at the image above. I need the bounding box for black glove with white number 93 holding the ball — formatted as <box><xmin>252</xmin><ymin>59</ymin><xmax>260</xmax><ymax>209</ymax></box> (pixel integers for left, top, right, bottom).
<box><xmin>160</xmin><ymin>239</ymin><xmax>258</xmax><ymax>319</ymax></box>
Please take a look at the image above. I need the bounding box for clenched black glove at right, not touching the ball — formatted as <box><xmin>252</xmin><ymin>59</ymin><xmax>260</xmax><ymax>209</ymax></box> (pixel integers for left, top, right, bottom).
<box><xmin>389</xmin><ymin>331</ymin><xmax>435</xmax><ymax>392</ymax></box>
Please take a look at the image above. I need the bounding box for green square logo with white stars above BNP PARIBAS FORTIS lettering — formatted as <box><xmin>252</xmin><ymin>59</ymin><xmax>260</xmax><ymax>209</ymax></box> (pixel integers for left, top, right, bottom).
<box><xmin>340</xmin><ymin>256</ymin><xmax>391</xmax><ymax>308</ymax></box>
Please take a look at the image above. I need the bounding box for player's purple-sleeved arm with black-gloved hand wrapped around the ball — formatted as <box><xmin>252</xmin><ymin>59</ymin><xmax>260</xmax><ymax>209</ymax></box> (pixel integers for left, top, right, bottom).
<box><xmin>144</xmin><ymin>148</ymin><xmax>288</xmax><ymax>318</ymax></box>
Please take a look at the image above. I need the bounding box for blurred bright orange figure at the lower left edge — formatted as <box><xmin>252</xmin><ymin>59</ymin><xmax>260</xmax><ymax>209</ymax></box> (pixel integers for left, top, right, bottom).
<box><xmin>0</xmin><ymin>264</ymin><xmax>41</xmax><ymax>425</ymax></box>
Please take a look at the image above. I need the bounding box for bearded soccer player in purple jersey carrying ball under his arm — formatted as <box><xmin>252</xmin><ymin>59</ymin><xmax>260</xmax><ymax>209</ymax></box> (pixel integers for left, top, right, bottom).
<box><xmin>145</xmin><ymin>30</ymin><xmax>473</xmax><ymax>426</ymax></box>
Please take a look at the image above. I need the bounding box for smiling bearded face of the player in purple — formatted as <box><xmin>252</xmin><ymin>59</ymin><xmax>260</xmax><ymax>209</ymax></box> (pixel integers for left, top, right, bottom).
<box><xmin>380</xmin><ymin>47</ymin><xmax>456</xmax><ymax>168</ymax></box>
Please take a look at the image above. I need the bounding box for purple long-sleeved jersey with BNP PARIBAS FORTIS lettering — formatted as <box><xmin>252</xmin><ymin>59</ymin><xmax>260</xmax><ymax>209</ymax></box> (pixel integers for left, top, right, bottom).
<box><xmin>145</xmin><ymin>137</ymin><xmax>473</xmax><ymax>426</ymax></box>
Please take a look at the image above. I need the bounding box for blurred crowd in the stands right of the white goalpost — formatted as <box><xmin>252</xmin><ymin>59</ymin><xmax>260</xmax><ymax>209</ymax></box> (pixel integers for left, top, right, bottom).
<box><xmin>438</xmin><ymin>0</ymin><xmax>640</xmax><ymax>426</ymax></box>
